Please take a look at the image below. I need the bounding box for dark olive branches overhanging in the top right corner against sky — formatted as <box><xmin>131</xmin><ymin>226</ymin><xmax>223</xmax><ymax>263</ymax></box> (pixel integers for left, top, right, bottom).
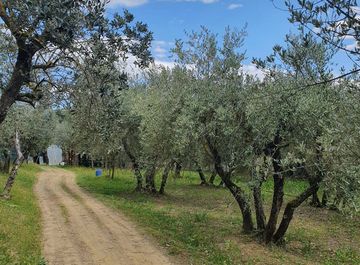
<box><xmin>285</xmin><ymin>0</ymin><xmax>360</xmax><ymax>78</ymax></box>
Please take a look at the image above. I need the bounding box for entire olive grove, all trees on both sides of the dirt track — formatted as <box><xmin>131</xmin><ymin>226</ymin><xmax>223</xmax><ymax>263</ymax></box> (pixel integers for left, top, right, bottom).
<box><xmin>0</xmin><ymin>0</ymin><xmax>360</xmax><ymax>244</ymax></box>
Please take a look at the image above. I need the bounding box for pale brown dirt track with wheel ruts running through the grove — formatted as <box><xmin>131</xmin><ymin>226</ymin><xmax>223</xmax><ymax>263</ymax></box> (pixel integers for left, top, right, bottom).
<box><xmin>35</xmin><ymin>168</ymin><xmax>171</xmax><ymax>265</ymax></box>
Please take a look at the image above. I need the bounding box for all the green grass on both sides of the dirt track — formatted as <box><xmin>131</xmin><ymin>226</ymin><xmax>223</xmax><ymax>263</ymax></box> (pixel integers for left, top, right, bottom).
<box><xmin>0</xmin><ymin>165</ymin><xmax>360</xmax><ymax>265</ymax></box>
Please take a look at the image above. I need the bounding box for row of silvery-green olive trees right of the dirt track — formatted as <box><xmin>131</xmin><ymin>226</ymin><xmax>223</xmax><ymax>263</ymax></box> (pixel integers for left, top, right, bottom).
<box><xmin>66</xmin><ymin>22</ymin><xmax>360</xmax><ymax>243</ymax></box>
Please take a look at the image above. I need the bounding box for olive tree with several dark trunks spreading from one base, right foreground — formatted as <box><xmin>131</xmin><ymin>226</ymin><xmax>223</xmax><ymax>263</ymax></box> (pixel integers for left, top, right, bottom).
<box><xmin>247</xmin><ymin>33</ymin><xmax>354</xmax><ymax>243</ymax></box>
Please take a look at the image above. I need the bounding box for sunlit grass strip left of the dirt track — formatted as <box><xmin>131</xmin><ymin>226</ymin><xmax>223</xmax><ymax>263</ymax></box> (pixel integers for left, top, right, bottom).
<box><xmin>0</xmin><ymin>164</ymin><xmax>44</xmax><ymax>265</ymax></box>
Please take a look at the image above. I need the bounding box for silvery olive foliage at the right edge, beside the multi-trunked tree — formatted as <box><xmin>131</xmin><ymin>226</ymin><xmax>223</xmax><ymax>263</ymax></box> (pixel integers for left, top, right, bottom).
<box><xmin>322</xmin><ymin>76</ymin><xmax>360</xmax><ymax>211</ymax></box>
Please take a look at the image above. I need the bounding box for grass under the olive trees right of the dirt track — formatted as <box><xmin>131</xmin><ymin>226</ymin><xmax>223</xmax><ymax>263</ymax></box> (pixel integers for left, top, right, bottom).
<box><xmin>70</xmin><ymin>168</ymin><xmax>360</xmax><ymax>265</ymax></box>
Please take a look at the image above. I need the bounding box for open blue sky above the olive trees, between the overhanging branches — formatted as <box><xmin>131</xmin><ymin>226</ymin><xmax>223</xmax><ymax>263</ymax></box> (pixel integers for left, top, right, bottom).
<box><xmin>108</xmin><ymin>0</ymin><xmax>354</xmax><ymax>71</ymax></box>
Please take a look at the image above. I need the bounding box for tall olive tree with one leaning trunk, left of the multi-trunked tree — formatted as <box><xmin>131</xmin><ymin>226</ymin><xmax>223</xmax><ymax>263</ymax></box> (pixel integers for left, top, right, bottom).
<box><xmin>170</xmin><ymin>28</ymin><xmax>254</xmax><ymax>232</ymax></box>
